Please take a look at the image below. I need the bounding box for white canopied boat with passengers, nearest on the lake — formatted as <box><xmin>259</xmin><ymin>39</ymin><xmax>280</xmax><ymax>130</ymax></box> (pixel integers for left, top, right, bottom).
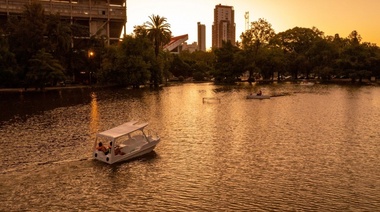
<box><xmin>93</xmin><ymin>121</ymin><xmax>160</xmax><ymax>164</ymax></box>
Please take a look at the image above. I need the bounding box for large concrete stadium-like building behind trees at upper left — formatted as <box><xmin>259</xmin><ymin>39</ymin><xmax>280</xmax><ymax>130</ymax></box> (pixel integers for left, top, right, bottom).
<box><xmin>0</xmin><ymin>0</ymin><xmax>127</xmax><ymax>45</ymax></box>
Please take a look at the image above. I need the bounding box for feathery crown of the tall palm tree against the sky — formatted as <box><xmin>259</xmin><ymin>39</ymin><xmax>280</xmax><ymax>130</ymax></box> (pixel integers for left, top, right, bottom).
<box><xmin>145</xmin><ymin>15</ymin><xmax>172</xmax><ymax>57</ymax></box>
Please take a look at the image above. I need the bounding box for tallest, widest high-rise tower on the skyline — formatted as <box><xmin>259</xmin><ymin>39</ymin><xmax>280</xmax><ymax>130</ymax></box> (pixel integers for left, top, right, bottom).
<box><xmin>212</xmin><ymin>4</ymin><xmax>236</xmax><ymax>48</ymax></box>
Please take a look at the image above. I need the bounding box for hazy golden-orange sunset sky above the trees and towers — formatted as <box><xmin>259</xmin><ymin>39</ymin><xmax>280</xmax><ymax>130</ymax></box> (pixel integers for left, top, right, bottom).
<box><xmin>126</xmin><ymin>0</ymin><xmax>380</xmax><ymax>49</ymax></box>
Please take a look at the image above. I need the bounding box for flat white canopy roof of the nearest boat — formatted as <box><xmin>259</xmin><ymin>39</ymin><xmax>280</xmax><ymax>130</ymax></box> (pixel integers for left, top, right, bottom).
<box><xmin>97</xmin><ymin>121</ymin><xmax>148</xmax><ymax>139</ymax></box>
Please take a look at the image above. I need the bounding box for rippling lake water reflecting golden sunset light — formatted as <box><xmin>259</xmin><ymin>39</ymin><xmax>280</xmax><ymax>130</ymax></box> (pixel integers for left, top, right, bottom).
<box><xmin>0</xmin><ymin>83</ymin><xmax>380</xmax><ymax>211</ymax></box>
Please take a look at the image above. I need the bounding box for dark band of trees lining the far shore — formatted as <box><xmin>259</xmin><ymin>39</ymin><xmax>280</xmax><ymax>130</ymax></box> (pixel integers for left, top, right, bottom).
<box><xmin>0</xmin><ymin>3</ymin><xmax>380</xmax><ymax>90</ymax></box>
